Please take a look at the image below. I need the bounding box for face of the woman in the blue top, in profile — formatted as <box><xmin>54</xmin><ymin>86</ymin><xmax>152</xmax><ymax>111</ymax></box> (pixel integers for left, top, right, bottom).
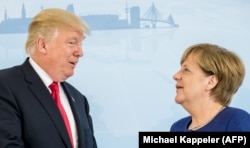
<box><xmin>173</xmin><ymin>55</ymin><xmax>209</xmax><ymax>105</ymax></box>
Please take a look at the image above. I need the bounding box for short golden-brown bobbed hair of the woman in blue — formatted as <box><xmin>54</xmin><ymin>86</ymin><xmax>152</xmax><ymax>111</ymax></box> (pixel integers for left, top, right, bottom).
<box><xmin>181</xmin><ymin>43</ymin><xmax>245</xmax><ymax>105</ymax></box>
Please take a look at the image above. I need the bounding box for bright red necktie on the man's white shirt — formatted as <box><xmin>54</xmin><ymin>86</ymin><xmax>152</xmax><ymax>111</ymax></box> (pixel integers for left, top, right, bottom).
<box><xmin>49</xmin><ymin>82</ymin><xmax>74</xmax><ymax>147</ymax></box>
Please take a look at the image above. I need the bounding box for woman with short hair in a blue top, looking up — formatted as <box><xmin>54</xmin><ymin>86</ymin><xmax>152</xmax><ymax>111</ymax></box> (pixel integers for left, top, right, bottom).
<box><xmin>170</xmin><ymin>43</ymin><xmax>250</xmax><ymax>132</ymax></box>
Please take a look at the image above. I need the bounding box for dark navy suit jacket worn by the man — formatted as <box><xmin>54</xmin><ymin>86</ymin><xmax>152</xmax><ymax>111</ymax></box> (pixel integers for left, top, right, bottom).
<box><xmin>0</xmin><ymin>58</ymin><xmax>97</xmax><ymax>148</ymax></box>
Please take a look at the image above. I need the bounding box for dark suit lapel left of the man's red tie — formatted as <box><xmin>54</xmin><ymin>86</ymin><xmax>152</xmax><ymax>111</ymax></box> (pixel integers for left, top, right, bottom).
<box><xmin>22</xmin><ymin>58</ymin><xmax>72</xmax><ymax>147</ymax></box>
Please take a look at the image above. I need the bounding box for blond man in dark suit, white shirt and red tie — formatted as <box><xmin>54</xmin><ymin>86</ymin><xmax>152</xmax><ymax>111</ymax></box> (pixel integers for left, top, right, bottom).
<box><xmin>0</xmin><ymin>8</ymin><xmax>97</xmax><ymax>148</ymax></box>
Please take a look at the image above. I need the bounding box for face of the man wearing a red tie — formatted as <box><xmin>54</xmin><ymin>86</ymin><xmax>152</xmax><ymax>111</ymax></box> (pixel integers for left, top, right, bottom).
<box><xmin>46</xmin><ymin>29</ymin><xmax>84</xmax><ymax>82</ymax></box>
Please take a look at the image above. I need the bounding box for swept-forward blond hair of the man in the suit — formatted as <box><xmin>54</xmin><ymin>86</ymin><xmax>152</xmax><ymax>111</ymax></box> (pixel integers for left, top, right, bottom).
<box><xmin>25</xmin><ymin>8</ymin><xmax>89</xmax><ymax>54</ymax></box>
